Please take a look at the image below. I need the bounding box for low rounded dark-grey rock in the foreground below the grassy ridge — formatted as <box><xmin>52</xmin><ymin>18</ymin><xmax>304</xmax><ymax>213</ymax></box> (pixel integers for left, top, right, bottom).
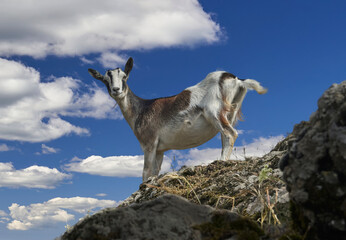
<box><xmin>60</xmin><ymin>195</ymin><xmax>264</xmax><ymax>240</ymax></box>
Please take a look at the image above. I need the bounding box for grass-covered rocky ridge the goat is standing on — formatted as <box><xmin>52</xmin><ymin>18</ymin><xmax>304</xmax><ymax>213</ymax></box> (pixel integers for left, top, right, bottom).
<box><xmin>120</xmin><ymin>137</ymin><xmax>290</xmax><ymax>223</ymax></box>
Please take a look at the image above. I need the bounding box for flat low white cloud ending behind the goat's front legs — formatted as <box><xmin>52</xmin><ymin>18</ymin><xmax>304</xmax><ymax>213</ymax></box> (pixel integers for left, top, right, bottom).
<box><xmin>65</xmin><ymin>155</ymin><xmax>170</xmax><ymax>177</ymax></box>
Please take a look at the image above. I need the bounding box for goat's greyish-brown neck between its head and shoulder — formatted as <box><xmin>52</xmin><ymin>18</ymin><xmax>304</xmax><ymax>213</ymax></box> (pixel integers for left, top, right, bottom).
<box><xmin>116</xmin><ymin>88</ymin><xmax>145</xmax><ymax>130</ymax></box>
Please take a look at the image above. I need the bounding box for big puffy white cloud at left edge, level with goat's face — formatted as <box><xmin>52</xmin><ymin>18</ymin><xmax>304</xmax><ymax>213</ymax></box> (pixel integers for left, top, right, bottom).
<box><xmin>0</xmin><ymin>58</ymin><xmax>121</xmax><ymax>142</ymax></box>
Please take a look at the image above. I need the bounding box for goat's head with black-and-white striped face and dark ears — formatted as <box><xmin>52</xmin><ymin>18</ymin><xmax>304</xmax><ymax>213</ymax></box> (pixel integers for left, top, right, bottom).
<box><xmin>88</xmin><ymin>57</ymin><xmax>133</xmax><ymax>98</ymax></box>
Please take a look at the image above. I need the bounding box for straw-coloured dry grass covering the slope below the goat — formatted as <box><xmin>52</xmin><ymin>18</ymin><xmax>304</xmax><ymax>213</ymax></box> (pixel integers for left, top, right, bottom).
<box><xmin>140</xmin><ymin>160</ymin><xmax>281</xmax><ymax>227</ymax></box>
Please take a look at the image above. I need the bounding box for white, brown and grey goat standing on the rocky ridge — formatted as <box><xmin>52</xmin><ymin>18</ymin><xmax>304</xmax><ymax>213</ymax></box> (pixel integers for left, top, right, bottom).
<box><xmin>88</xmin><ymin>58</ymin><xmax>267</xmax><ymax>181</ymax></box>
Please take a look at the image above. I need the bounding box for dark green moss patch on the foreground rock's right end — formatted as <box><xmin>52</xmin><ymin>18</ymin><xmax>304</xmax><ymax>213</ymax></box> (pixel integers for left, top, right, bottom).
<box><xmin>194</xmin><ymin>211</ymin><xmax>264</xmax><ymax>240</ymax></box>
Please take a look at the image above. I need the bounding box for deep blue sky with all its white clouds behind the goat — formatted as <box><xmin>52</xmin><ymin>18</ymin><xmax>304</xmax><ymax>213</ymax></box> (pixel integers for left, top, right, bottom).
<box><xmin>0</xmin><ymin>0</ymin><xmax>346</xmax><ymax>240</ymax></box>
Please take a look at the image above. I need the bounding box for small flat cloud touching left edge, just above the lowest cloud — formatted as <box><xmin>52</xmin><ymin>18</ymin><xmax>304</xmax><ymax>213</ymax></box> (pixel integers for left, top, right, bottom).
<box><xmin>0</xmin><ymin>162</ymin><xmax>71</xmax><ymax>189</ymax></box>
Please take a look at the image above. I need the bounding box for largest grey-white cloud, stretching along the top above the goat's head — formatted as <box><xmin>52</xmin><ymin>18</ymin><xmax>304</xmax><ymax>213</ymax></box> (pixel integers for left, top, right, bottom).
<box><xmin>0</xmin><ymin>0</ymin><xmax>221</xmax><ymax>62</ymax></box>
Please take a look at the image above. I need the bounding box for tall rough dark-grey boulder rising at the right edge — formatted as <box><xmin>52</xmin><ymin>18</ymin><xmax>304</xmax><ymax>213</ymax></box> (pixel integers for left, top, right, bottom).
<box><xmin>280</xmin><ymin>81</ymin><xmax>346</xmax><ymax>240</ymax></box>
